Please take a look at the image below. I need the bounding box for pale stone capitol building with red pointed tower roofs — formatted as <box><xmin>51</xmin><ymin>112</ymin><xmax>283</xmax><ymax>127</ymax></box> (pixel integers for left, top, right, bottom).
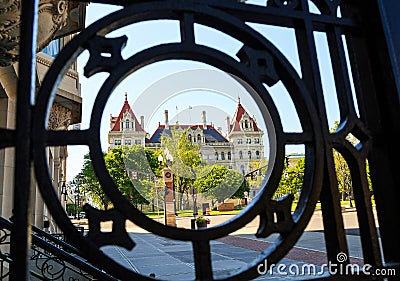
<box><xmin>108</xmin><ymin>94</ymin><xmax>264</xmax><ymax>174</ymax></box>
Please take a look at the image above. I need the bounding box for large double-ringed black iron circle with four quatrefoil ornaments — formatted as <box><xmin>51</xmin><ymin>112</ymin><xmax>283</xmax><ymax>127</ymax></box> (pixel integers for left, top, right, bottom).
<box><xmin>33</xmin><ymin>1</ymin><xmax>323</xmax><ymax>280</ymax></box>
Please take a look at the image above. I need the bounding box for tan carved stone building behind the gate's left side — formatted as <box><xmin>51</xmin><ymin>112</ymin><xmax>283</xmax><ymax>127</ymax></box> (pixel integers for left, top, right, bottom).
<box><xmin>0</xmin><ymin>0</ymin><xmax>87</xmax><ymax>232</ymax></box>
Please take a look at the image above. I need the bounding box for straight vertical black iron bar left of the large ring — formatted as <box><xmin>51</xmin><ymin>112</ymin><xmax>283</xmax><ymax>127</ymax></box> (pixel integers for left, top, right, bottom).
<box><xmin>10</xmin><ymin>0</ymin><xmax>39</xmax><ymax>280</ymax></box>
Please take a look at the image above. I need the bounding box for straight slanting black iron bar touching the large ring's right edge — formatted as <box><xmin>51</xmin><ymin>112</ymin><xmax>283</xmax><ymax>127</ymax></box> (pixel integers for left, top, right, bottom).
<box><xmin>295</xmin><ymin>0</ymin><xmax>348</xmax><ymax>262</ymax></box>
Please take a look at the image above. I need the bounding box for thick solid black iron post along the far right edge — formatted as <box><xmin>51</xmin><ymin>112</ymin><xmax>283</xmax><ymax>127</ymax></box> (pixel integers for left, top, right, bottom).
<box><xmin>342</xmin><ymin>0</ymin><xmax>400</xmax><ymax>262</ymax></box>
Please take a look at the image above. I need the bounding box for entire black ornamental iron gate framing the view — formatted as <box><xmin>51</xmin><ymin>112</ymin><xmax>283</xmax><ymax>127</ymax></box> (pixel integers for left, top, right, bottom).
<box><xmin>0</xmin><ymin>0</ymin><xmax>400</xmax><ymax>280</ymax></box>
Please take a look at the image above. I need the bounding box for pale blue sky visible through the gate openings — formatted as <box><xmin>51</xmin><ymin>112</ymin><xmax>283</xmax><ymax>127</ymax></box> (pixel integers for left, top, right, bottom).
<box><xmin>67</xmin><ymin>1</ymin><xmax>339</xmax><ymax>181</ymax></box>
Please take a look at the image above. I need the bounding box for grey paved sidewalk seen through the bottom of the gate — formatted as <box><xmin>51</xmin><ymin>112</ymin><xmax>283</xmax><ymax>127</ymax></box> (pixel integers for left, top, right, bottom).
<box><xmin>98</xmin><ymin>211</ymin><xmax>368</xmax><ymax>280</ymax></box>
